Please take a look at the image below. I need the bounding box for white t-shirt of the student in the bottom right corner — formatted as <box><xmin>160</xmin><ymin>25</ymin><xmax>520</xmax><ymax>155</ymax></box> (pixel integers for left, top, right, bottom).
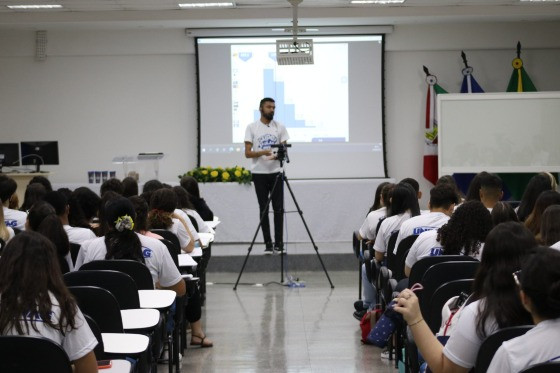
<box><xmin>487</xmin><ymin>319</ymin><xmax>560</xmax><ymax>373</ymax></box>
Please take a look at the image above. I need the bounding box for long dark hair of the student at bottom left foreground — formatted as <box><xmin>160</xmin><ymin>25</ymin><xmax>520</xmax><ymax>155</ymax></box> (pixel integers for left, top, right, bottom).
<box><xmin>0</xmin><ymin>231</ymin><xmax>77</xmax><ymax>335</ymax></box>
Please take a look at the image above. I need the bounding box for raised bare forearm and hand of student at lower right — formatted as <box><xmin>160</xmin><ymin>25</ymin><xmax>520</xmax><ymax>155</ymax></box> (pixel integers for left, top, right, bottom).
<box><xmin>394</xmin><ymin>289</ymin><xmax>470</xmax><ymax>373</ymax></box>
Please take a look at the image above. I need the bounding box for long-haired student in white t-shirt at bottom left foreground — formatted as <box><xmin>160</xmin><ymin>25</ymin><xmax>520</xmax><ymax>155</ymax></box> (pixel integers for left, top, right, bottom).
<box><xmin>0</xmin><ymin>232</ymin><xmax>97</xmax><ymax>373</ymax></box>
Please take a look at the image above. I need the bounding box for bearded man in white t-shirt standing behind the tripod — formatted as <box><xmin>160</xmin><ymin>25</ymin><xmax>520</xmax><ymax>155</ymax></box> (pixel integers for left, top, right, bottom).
<box><xmin>245</xmin><ymin>97</ymin><xmax>289</xmax><ymax>255</ymax></box>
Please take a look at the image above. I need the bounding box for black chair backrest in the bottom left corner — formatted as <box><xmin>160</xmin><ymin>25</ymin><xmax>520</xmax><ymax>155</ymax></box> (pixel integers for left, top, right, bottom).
<box><xmin>0</xmin><ymin>335</ymin><xmax>72</xmax><ymax>373</ymax></box>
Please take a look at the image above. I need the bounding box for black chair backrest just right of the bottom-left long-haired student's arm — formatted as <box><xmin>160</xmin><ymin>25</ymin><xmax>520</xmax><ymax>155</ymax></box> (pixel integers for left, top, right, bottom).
<box><xmin>68</xmin><ymin>286</ymin><xmax>124</xmax><ymax>333</ymax></box>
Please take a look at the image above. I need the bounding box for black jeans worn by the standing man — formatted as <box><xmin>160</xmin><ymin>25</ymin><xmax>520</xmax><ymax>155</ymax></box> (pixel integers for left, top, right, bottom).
<box><xmin>252</xmin><ymin>172</ymin><xmax>284</xmax><ymax>245</ymax></box>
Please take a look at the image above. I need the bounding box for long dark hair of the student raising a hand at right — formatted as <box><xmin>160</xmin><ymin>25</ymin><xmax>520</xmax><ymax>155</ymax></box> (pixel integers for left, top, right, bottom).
<box><xmin>473</xmin><ymin>222</ymin><xmax>537</xmax><ymax>338</ymax></box>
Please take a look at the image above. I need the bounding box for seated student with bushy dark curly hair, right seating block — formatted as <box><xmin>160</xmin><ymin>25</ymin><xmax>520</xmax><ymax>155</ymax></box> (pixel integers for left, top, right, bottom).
<box><xmin>404</xmin><ymin>201</ymin><xmax>493</xmax><ymax>277</ymax></box>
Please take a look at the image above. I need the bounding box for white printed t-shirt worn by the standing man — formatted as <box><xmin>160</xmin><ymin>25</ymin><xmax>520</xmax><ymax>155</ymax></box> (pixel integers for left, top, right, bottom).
<box><xmin>245</xmin><ymin>119</ymin><xmax>290</xmax><ymax>174</ymax></box>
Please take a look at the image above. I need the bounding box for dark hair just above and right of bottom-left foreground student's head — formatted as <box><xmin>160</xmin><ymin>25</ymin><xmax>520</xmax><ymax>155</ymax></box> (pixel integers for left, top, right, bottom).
<box><xmin>27</xmin><ymin>201</ymin><xmax>70</xmax><ymax>272</ymax></box>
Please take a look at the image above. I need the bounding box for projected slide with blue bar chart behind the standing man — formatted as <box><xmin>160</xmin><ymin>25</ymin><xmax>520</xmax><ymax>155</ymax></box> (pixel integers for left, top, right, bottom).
<box><xmin>231</xmin><ymin>43</ymin><xmax>349</xmax><ymax>143</ymax></box>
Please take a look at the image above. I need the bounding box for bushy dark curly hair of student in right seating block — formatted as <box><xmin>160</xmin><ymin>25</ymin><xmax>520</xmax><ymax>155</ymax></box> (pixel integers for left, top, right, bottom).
<box><xmin>437</xmin><ymin>201</ymin><xmax>492</xmax><ymax>256</ymax></box>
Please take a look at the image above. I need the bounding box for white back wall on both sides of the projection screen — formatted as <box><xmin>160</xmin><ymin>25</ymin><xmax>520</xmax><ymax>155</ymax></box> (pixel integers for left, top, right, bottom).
<box><xmin>0</xmin><ymin>22</ymin><xmax>560</xmax><ymax>206</ymax></box>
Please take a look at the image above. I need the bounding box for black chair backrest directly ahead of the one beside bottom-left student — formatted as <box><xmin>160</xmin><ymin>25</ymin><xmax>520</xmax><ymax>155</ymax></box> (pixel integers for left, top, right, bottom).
<box><xmin>64</xmin><ymin>270</ymin><xmax>140</xmax><ymax>310</ymax></box>
